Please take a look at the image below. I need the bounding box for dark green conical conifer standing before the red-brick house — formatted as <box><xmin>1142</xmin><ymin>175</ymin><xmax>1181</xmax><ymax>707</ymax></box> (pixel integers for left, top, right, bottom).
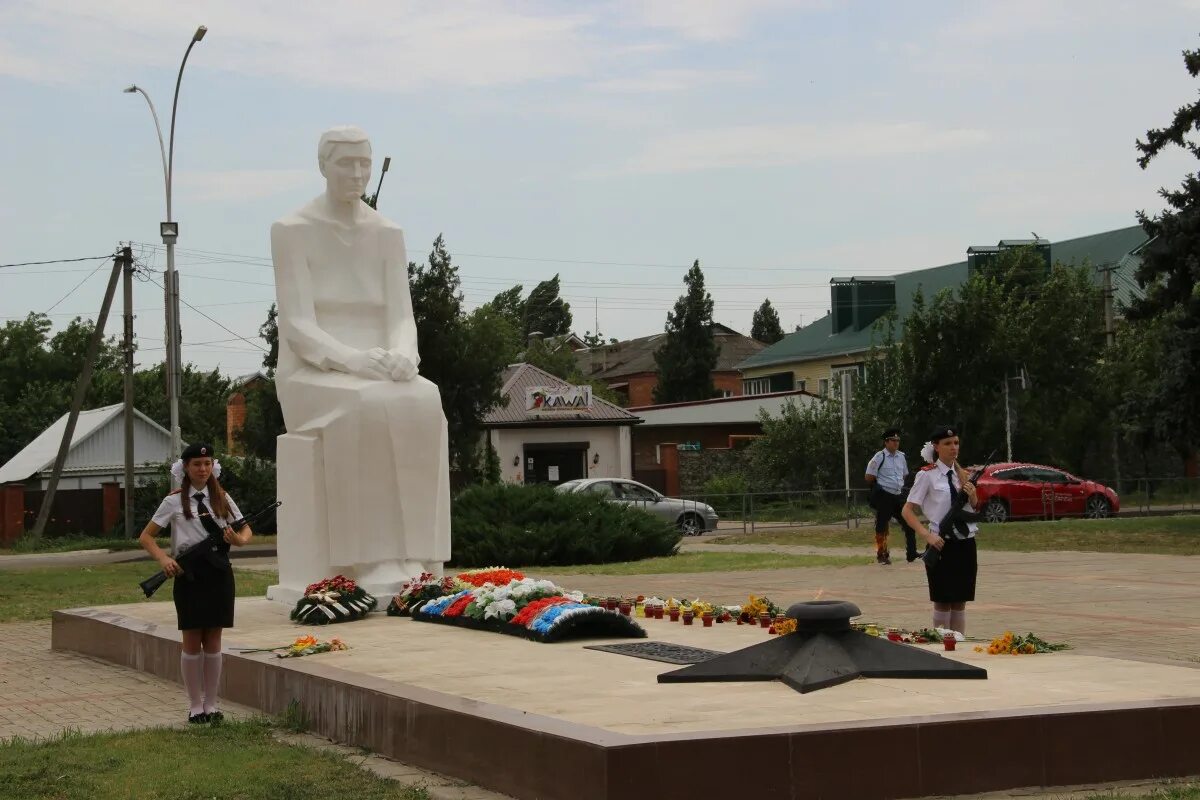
<box><xmin>654</xmin><ymin>259</ymin><xmax>718</xmax><ymax>403</ymax></box>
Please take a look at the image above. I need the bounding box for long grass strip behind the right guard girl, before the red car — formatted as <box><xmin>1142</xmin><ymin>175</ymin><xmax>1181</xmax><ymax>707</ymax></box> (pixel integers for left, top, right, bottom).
<box><xmin>712</xmin><ymin>515</ymin><xmax>1200</xmax><ymax>555</ymax></box>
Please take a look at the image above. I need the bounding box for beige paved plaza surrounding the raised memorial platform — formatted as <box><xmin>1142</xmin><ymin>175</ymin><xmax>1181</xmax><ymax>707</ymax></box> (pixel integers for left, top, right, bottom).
<box><xmin>0</xmin><ymin>542</ymin><xmax>1200</xmax><ymax>798</ymax></box>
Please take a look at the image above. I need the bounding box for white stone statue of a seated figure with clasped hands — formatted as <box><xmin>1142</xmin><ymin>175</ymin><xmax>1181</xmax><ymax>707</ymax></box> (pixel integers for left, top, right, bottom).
<box><xmin>268</xmin><ymin>127</ymin><xmax>450</xmax><ymax>602</ymax></box>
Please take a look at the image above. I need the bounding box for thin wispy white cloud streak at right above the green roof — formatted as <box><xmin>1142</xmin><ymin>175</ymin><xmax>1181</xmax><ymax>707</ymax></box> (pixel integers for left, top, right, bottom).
<box><xmin>590</xmin><ymin>122</ymin><xmax>988</xmax><ymax>178</ymax></box>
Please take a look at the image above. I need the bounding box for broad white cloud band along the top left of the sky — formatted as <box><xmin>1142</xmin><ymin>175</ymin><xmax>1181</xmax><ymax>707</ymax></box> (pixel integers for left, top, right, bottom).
<box><xmin>0</xmin><ymin>0</ymin><xmax>601</xmax><ymax>90</ymax></box>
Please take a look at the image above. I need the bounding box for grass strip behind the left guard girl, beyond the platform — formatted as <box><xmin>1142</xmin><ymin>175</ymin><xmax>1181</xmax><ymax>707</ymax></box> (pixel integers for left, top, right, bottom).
<box><xmin>0</xmin><ymin>561</ymin><xmax>278</xmax><ymax>623</ymax></box>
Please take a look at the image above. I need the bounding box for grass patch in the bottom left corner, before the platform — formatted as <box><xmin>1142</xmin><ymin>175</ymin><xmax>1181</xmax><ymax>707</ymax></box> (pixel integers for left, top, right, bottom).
<box><xmin>0</xmin><ymin>720</ymin><xmax>428</xmax><ymax>800</ymax></box>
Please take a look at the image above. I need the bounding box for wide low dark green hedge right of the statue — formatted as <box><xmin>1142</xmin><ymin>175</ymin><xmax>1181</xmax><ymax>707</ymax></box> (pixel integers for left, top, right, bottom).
<box><xmin>451</xmin><ymin>483</ymin><xmax>679</xmax><ymax>567</ymax></box>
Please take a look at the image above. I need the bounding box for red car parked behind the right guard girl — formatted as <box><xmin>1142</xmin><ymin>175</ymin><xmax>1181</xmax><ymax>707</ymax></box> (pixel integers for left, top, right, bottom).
<box><xmin>971</xmin><ymin>463</ymin><xmax>1121</xmax><ymax>522</ymax></box>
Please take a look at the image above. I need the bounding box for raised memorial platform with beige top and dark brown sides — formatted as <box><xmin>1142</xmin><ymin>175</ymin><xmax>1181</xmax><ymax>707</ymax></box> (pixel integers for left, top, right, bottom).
<box><xmin>53</xmin><ymin>599</ymin><xmax>1200</xmax><ymax>800</ymax></box>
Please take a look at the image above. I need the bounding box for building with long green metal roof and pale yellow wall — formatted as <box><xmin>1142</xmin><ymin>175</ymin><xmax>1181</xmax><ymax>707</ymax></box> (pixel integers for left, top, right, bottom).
<box><xmin>737</xmin><ymin>225</ymin><xmax>1147</xmax><ymax>395</ymax></box>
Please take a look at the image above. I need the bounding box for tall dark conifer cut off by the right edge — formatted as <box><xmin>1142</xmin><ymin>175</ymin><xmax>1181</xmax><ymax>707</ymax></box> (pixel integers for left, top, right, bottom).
<box><xmin>1129</xmin><ymin>40</ymin><xmax>1200</xmax><ymax>457</ymax></box>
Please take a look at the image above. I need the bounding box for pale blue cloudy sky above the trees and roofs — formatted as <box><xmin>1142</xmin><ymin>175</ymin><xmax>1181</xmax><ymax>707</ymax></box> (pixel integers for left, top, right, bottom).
<box><xmin>0</xmin><ymin>0</ymin><xmax>1200</xmax><ymax>374</ymax></box>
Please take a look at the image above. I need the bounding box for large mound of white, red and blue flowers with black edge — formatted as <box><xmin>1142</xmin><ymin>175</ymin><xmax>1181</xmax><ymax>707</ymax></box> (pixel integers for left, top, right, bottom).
<box><xmin>409</xmin><ymin>578</ymin><xmax>646</xmax><ymax>642</ymax></box>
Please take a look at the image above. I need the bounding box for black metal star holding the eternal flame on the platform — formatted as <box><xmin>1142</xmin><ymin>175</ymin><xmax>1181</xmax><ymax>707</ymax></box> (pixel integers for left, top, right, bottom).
<box><xmin>659</xmin><ymin>600</ymin><xmax>988</xmax><ymax>693</ymax></box>
